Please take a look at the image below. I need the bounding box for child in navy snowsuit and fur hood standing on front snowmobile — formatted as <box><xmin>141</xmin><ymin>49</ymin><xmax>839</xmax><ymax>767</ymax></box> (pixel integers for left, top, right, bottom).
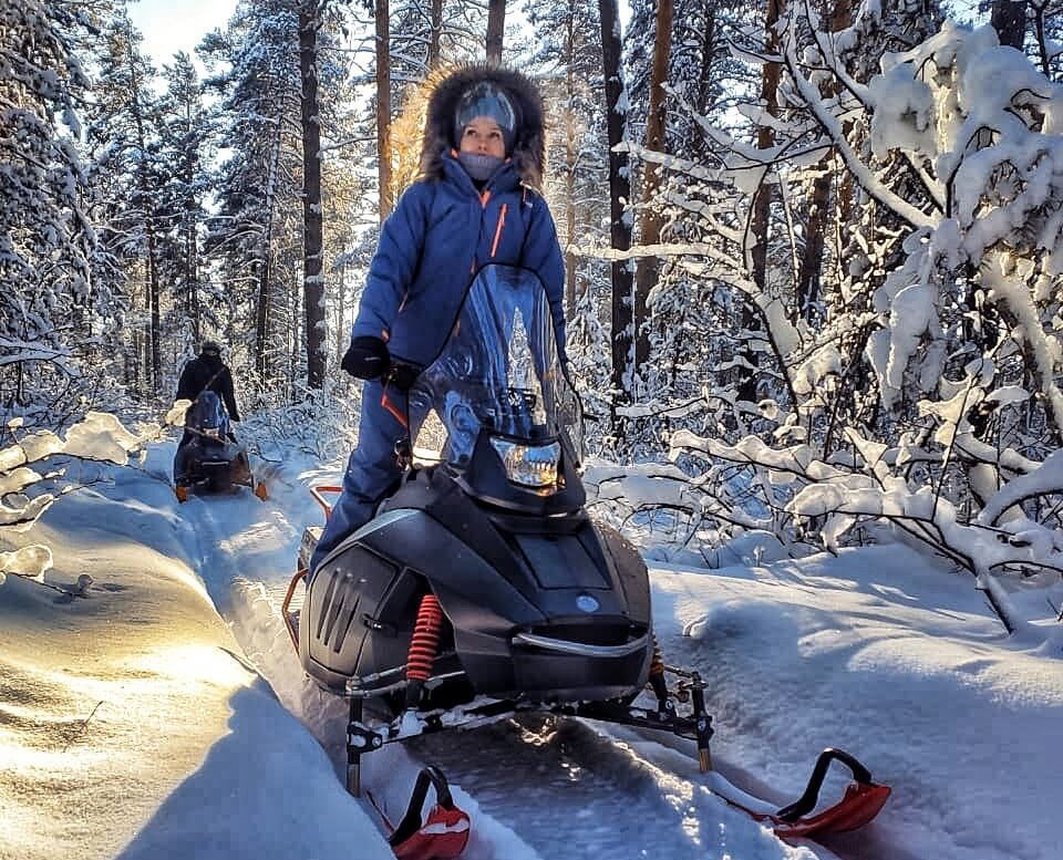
<box><xmin>310</xmin><ymin>66</ymin><xmax>564</xmax><ymax>574</ymax></box>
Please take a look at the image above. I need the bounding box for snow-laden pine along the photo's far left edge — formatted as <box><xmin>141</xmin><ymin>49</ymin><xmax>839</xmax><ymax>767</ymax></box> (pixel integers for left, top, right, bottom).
<box><xmin>0</xmin><ymin>0</ymin><xmax>113</xmax><ymax>429</ymax></box>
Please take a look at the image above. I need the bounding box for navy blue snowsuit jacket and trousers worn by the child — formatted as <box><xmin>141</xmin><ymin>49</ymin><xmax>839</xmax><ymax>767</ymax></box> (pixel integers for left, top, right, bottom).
<box><xmin>310</xmin><ymin>152</ymin><xmax>564</xmax><ymax>572</ymax></box>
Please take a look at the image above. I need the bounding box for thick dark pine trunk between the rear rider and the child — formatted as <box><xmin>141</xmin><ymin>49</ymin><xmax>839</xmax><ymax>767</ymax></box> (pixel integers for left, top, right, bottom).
<box><xmin>299</xmin><ymin>0</ymin><xmax>325</xmax><ymax>389</ymax></box>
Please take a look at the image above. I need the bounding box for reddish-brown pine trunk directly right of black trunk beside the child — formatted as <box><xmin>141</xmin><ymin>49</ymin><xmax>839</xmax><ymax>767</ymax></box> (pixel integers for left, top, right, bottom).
<box><xmin>635</xmin><ymin>0</ymin><xmax>672</xmax><ymax>372</ymax></box>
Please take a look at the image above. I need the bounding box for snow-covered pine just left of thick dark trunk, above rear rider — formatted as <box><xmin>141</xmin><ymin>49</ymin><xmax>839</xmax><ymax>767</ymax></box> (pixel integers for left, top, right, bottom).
<box><xmin>200</xmin><ymin>0</ymin><xmax>303</xmax><ymax>399</ymax></box>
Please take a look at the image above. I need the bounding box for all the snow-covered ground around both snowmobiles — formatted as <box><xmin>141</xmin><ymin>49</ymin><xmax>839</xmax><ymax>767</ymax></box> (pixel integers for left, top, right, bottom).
<box><xmin>0</xmin><ymin>442</ymin><xmax>1063</xmax><ymax>860</ymax></box>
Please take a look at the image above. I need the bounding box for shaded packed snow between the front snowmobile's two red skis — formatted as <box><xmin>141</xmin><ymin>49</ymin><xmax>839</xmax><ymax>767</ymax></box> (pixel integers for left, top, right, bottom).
<box><xmin>401</xmin><ymin>716</ymin><xmax>837</xmax><ymax>860</ymax></box>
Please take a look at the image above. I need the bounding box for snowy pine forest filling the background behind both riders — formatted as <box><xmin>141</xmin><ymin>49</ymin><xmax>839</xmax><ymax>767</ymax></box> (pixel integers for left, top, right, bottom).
<box><xmin>0</xmin><ymin>0</ymin><xmax>1063</xmax><ymax>612</ymax></box>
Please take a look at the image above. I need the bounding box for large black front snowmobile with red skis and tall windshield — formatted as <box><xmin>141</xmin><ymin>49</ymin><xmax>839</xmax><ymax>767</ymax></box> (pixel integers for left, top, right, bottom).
<box><xmin>282</xmin><ymin>266</ymin><xmax>890</xmax><ymax>857</ymax></box>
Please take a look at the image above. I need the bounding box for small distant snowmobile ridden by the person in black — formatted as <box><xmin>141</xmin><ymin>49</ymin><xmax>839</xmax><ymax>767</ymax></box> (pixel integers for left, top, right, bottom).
<box><xmin>173</xmin><ymin>389</ymin><xmax>269</xmax><ymax>502</ymax></box>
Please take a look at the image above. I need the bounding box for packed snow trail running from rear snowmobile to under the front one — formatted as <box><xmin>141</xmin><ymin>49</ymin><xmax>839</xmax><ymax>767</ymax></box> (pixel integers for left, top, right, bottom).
<box><xmin>182</xmin><ymin>448</ymin><xmax>834</xmax><ymax>860</ymax></box>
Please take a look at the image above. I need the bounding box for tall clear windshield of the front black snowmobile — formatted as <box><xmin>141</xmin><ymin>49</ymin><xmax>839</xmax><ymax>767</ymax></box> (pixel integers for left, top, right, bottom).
<box><xmin>409</xmin><ymin>265</ymin><xmax>583</xmax><ymax>468</ymax></box>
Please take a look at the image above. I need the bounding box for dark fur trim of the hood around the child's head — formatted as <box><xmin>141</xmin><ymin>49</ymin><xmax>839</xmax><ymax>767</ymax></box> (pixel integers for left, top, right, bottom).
<box><xmin>420</xmin><ymin>65</ymin><xmax>546</xmax><ymax>188</ymax></box>
